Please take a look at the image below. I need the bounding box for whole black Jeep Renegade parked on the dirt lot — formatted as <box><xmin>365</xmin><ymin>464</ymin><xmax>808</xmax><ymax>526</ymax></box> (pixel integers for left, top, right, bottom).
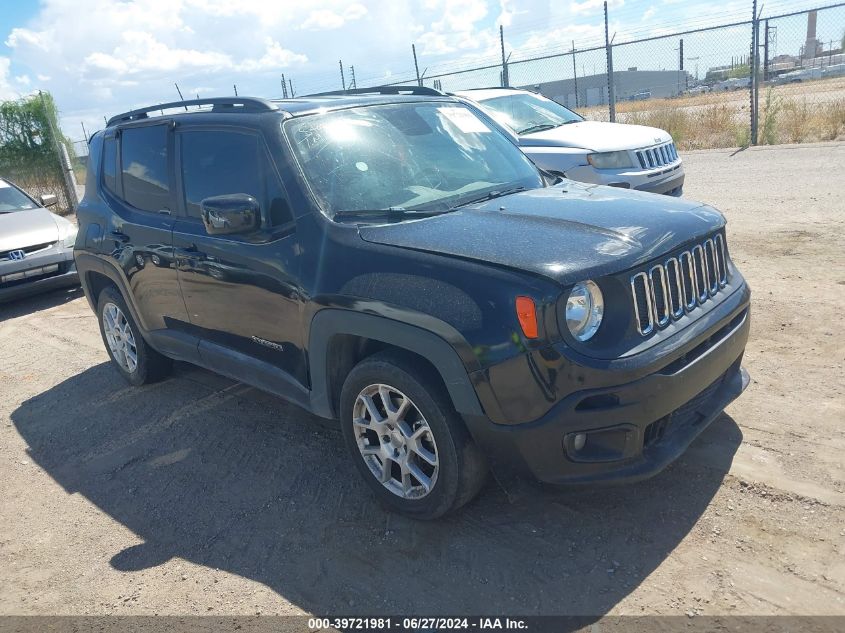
<box><xmin>75</xmin><ymin>88</ymin><xmax>750</xmax><ymax>518</ymax></box>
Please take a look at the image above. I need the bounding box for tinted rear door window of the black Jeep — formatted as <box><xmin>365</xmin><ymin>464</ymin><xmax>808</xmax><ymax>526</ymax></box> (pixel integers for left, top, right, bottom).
<box><xmin>120</xmin><ymin>125</ymin><xmax>170</xmax><ymax>212</ymax></box>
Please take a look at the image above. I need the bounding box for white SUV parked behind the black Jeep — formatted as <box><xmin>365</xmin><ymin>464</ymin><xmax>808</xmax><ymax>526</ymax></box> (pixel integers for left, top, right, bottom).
<box><xmin>455</xmin><ymin>88</ymin><xmax>684</xmax><ymax>196</ymax></box>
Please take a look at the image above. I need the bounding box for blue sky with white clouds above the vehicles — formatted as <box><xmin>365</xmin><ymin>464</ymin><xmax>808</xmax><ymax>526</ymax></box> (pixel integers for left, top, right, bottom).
<box><xmin>0</xmin><ymin>0</ymin><xmax>845</xmax><ymax>138</ymax></box>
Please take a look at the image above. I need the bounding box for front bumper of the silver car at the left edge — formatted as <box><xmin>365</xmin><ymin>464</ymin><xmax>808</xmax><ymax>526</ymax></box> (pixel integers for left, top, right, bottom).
<box><xmin>0</xmin><ymin>244</ymin><xmax>79</xmax><ymax>303</ymax></box>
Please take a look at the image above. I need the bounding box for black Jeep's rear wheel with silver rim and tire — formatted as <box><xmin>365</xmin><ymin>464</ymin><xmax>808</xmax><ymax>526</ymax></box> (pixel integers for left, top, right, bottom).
<box><xmin>97</xmin><ymin>286</ymin><xmax>173</xmax><ymax>386</ymax></box>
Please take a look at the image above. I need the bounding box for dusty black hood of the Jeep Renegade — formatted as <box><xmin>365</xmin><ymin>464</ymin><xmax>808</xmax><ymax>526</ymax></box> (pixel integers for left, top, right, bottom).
<box><xmin>360</xmin><ymin>182</ymin><xmax>725</xmax><ymax>285</ymax></box>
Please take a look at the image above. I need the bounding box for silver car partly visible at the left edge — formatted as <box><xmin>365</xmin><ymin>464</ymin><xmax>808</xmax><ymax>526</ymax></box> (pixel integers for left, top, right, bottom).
<box><xmin>0</xmin><ymin>178</ymin><xmax>79</xmax><ymax>303</ymax></box>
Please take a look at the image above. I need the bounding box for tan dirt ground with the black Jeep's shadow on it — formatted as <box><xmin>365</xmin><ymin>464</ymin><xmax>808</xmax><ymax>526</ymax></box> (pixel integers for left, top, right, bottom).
<box><xmin>0</xmin><ymin>143</ymin><xmax>845</xmax><ymax>616</ymax></box>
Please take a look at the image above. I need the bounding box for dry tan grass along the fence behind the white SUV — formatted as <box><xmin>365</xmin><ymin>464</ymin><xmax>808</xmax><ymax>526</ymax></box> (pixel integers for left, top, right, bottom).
<box><xmin>582</xmin><ymin>77</ymin><xmax>845</xmax><ymax>150</ymax></box>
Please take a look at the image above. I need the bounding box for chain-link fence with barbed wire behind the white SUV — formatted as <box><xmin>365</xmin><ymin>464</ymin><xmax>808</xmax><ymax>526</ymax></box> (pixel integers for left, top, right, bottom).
<box><xmin>356</xmin><ymin>0</ymin><xmax>845</xmax><ymax>149</ymax></box>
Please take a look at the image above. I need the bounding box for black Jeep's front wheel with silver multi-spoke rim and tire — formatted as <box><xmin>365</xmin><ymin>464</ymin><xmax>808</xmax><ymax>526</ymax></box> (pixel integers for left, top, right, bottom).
<box><xmin>340</xmin><ymin>352</ymin><xmax>487</xmax><ymax>519</ymax></box>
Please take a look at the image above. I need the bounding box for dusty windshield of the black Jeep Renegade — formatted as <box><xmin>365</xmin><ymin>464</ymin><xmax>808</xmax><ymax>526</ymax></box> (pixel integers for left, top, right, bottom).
<box><xmin>284</xmin><ymin>102</ymin><xmax>543</xmax><ymax>216</ymax></box>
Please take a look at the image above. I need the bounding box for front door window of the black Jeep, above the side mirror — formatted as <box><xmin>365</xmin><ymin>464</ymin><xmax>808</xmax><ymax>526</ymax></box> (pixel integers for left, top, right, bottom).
<box><xmin>180</xmin><ymin>130</ymin><xmax>293</xmax><ymax>226</ymax></box>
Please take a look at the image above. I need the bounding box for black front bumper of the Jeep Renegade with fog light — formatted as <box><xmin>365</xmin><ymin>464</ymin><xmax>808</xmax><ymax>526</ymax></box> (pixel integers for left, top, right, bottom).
<box><xmin>465</xmin><ymin>289</ymin><xmax>750</xmax><ymax>484</ymax></box>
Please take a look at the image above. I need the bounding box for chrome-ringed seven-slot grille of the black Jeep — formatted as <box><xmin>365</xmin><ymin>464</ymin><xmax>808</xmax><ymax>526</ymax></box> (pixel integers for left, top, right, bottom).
<box><xmin>631</xmin><ymin>233</ymin><xmax>728</xmax><ymax>336</ymax></box>
